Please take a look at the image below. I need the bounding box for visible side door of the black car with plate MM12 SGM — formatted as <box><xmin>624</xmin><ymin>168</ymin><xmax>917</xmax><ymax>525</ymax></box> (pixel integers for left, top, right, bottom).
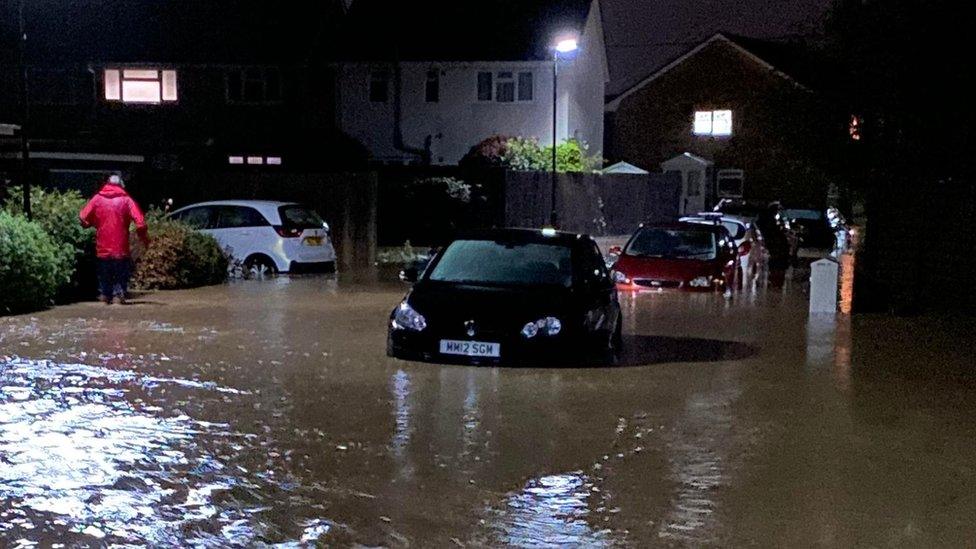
<box><xmin>579</xmin><ymin>242</ymin><xmax>620</xmax><ymax>338</ymax></box>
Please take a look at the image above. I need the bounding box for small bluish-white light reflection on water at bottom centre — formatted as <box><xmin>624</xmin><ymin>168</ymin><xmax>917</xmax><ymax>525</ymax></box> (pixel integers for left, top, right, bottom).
<box><xmin>493</xmin><ymin>471</ymin><xmax>612</xmax><ymax>547</ymax></box>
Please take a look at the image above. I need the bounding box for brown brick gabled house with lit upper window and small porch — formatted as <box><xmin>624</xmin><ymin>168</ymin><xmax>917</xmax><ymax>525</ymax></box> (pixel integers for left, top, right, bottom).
<box><xmin>605</xmin><ymin>33</ymin><xmax>840</xmax><ymax>211</ymax></box>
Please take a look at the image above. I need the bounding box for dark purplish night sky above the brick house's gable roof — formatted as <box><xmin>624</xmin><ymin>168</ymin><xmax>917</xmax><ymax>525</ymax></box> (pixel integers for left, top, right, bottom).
<box><xmin>601</xmin><ymin>0</ymin><xmax>831</xmax><ymax>95</ymax></box>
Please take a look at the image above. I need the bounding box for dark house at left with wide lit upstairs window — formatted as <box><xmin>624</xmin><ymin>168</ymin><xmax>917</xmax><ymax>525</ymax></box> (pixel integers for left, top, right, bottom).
<box><xmin>0</xmin><ymin>0</ymin><xmax>365</xmax><ymax>188</ymax></box>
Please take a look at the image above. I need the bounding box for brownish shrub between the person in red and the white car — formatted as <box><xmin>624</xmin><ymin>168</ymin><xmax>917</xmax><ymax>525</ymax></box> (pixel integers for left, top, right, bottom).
<box><xmin>132</xmin><ymin>210</ymin><xmax>230</xmax><ymax>290</ymax></box>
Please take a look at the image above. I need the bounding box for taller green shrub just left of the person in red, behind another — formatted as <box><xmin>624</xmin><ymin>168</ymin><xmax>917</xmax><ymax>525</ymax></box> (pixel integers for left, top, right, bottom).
<box><xmin>3</xmin><ymin>187</ymin><xmax>95</xmax><ymax>297</ymax></box>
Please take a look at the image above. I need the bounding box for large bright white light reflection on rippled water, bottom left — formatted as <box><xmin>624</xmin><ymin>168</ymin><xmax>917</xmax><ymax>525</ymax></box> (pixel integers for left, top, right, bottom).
<box><xmin>0</xmin><ymin>360</ymin><xmax>334</xmax><ymax>547</ymax></box>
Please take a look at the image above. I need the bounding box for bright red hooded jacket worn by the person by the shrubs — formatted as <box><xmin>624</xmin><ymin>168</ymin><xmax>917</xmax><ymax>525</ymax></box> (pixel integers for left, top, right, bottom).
<box><xmin>78</xmin><ymin>183</ymin><xmax>149</xmax><ymax>259</ymax></box>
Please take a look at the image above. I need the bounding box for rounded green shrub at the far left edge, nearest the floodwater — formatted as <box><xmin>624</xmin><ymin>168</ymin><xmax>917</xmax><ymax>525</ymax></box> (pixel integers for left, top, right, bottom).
<box><xmin>0</xmin><ymin>211</ymin><xmax>70</xmax><ymax>313</ymax></box>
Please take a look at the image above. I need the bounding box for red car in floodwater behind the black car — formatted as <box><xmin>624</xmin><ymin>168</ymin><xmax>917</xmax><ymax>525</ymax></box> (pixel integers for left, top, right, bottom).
<box><xmin>610</xmin><ymin>222</ymin><xmax>738</xmax><ymax>292</ymax></box>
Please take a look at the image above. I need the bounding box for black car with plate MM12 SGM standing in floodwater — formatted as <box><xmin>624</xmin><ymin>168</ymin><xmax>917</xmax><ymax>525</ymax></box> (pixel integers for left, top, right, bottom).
<box><xmin>387</xmin><ymin>229</ymin><xmax>622</xmax><ymax>364</ymax></box>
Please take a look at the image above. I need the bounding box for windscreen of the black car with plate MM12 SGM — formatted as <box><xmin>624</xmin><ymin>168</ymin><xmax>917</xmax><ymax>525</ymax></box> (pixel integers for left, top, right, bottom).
<box><xmin>427</xmin><ymin>240</ymin><xmax>573</xmax><ymax>288</ymax></box>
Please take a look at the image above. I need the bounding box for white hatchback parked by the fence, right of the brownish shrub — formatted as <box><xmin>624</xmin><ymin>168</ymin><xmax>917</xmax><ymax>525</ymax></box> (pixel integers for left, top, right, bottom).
<box><xmin>170</xmin><ymin>200</ymin><xmax>336</xmax><ymax>275</ymax></box>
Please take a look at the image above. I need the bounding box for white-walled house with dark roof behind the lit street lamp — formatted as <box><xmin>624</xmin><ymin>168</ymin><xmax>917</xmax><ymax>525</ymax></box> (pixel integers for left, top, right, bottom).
<box><xmin>336</xmin><ymin>0</ymin><xmax>609</xmax><ymax>165</ymax></box>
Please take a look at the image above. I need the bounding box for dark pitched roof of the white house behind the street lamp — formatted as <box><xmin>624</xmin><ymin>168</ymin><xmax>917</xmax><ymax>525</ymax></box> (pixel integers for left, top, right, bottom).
<box><xmin>342</xmin><ymin>0</ymin><xmax>591</xmax><ymax>61</ymax></box>
